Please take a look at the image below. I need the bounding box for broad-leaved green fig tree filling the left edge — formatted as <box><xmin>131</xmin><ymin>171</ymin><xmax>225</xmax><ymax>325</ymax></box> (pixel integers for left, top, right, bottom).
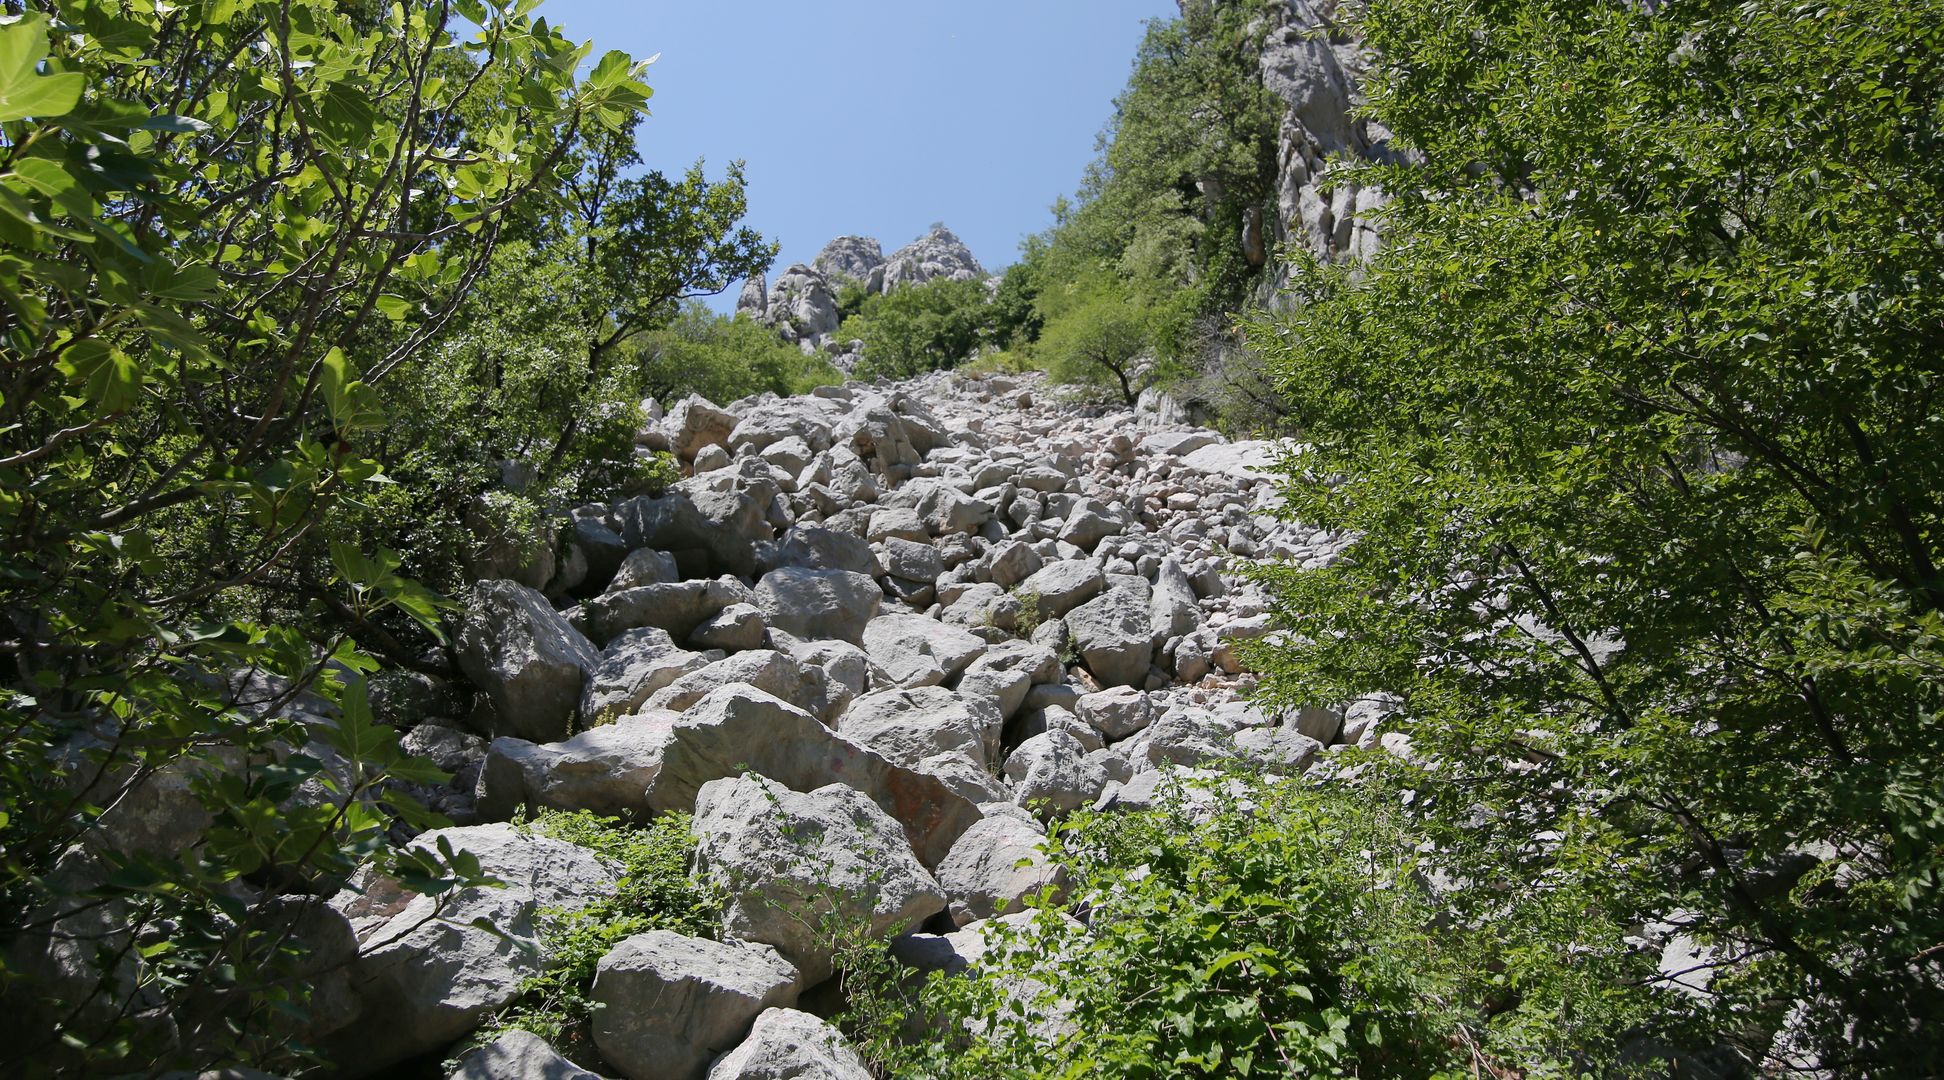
<box><xmin>0</xmin><ymin>0</ymin><xmax>649</xmax><ymax>1074</ymax></box>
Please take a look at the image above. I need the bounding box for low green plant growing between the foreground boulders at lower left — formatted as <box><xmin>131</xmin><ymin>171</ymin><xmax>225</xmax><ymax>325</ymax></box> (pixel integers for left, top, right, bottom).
<box><xmin>445</xmin><ymin>810</ymin><xmax>721</xmax><ymax>1074</ymax></box>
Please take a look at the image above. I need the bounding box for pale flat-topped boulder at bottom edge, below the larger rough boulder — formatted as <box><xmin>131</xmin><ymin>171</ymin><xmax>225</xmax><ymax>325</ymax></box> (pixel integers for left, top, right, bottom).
<box><xmin>589</xmin><ymin>930</ymin><xmax>797</xmax><ymax>1080</ymax></box>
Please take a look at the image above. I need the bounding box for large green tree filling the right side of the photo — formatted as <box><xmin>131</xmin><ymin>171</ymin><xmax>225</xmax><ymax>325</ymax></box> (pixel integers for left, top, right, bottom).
<box><xmin>1254</xmin><ymin>0</ymin><xmax>1944</xmax><ymax>1076</ymax></box>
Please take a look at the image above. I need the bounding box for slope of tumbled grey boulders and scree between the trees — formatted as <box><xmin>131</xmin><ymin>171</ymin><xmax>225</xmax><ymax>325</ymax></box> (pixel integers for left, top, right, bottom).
<box><xmin>330</xmin><ymin>373</ymin><xmax>1378</xmax><ymax>1080</ymax></box>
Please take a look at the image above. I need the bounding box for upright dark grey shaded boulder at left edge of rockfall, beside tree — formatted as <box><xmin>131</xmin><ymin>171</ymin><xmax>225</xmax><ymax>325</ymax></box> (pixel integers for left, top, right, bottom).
<box><xmin>457</xmin><ymin>581</ymin><xmax>601</xmax><ymax>742</ymax></box>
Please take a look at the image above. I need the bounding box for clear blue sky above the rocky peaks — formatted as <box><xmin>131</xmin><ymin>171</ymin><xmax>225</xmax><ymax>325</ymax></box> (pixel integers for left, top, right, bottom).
<box><xmin>538</xmin><ymin>0</ymin><xmax>1176</xmax><ymax>311</ymax></box>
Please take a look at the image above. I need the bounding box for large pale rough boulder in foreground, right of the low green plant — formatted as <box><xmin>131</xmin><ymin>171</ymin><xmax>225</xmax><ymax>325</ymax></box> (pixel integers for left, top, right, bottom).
<box><xmin>694</xmin><ymin>777</ymin><xmax>945</xmax><ymax>983</ymax></box>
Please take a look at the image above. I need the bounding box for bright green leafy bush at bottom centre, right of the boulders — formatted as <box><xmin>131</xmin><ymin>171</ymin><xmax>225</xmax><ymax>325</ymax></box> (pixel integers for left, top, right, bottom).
<box><xmin>892</xmin><ymin>773</ymin><xmax>1654</xmax><ymax>1080</ymax></box>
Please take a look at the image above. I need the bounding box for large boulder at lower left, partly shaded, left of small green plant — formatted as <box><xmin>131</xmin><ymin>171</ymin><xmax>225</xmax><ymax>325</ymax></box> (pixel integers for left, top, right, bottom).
<box><xmin>327</xmin><ymin>826</ymin><xmax>620</xmax><ymax>1076</ymax></box>
